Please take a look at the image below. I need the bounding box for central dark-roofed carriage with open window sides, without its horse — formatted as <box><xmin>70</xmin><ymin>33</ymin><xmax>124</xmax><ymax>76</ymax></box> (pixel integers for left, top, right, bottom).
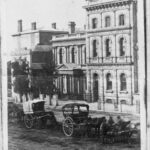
<box><xmin>62</xmin><ymin>103</ymin><xmax>89</xmax><ymax>136</ymax></box>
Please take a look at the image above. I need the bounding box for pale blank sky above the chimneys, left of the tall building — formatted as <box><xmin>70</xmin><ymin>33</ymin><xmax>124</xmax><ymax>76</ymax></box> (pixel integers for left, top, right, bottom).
<box><xmin>5</xmin><ymin>0</ymin><xmax>86</xmax><ymax>52</ymax></box>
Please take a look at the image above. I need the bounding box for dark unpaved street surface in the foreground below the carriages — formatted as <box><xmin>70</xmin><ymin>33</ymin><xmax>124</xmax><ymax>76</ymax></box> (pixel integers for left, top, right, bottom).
<box><xmin>8</xmin><ymin>109</ymin><xmax>140</xmax><ymax>150</ymax></box>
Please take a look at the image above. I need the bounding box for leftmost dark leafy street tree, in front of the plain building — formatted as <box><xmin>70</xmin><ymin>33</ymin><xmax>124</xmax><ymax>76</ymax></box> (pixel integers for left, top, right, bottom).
<box><xmin>11</xmin><ymin>58</ymin><xmax>29</xmax><ymax>102</ymax></box>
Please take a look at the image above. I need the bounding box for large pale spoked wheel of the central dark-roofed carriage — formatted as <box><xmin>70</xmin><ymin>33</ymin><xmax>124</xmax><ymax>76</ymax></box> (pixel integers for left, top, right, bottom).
<box><xmin>62</xmin><ymin>117</ymin><xmax>74</xmax><ymax>136</ymax></box>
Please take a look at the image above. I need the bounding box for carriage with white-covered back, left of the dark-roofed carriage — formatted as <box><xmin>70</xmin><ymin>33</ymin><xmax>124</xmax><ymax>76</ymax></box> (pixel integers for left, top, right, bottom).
<box><xmin>23</xmin><ymin>100</ymin><xmax>56</xmax><ymax>129</ymax></box>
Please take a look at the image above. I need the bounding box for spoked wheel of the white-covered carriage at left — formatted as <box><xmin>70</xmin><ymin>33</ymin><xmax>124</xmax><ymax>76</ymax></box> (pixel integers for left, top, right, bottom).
<box><xmin>24</xmin><ymin>114</ymin><xmax>34</xmax><ymax>129</ymax></box>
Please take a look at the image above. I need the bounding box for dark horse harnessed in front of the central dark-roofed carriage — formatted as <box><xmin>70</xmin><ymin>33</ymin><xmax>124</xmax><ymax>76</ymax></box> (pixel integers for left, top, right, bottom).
<box><xmin>88</xmin><ymin>117</ymin><xmax>106</xmax><ymax>137</ymax></box>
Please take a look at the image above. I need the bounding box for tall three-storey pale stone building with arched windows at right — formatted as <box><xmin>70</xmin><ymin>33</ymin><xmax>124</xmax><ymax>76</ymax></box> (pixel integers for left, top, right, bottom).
<box><xmin>84</xmin><ymin>0</ymin><xmax>138</xmax><ymax>111</ymax></box>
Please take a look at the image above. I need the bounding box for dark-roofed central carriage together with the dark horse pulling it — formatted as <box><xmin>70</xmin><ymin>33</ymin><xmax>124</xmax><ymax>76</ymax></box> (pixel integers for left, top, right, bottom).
<box><xmin>62</xmin><ymin>103</ymin><xmax>105</xmax><ymax>137</ymax></box>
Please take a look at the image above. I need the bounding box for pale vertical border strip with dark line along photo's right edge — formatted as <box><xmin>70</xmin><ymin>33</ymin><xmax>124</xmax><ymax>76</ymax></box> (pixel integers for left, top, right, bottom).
<box><xmin>138</xmin><ymin>0</ymin><xmax>150</xmax><ymax>150</ymax></box>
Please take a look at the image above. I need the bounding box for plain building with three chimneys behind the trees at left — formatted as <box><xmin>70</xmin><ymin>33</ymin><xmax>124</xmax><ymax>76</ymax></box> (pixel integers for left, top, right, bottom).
<box><xmin>8</xmin><ymin>20</ymin><xmax>68</xmax><ymax>101</ymax></box>
